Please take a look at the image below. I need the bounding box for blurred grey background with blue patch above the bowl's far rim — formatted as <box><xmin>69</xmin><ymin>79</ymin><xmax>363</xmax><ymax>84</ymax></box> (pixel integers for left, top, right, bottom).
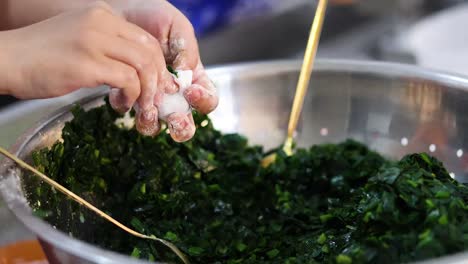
<box><xmin>0</xmin><ymin>0</ymin><xmax>468</xmax><ymax>108</ymax></box>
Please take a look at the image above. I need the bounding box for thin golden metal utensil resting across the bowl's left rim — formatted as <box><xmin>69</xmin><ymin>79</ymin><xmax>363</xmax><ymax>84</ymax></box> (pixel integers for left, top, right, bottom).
<box><xmin>0</xmin><ymin>147</ymin><xmax>189</xmax><ymax>264</ymax></box>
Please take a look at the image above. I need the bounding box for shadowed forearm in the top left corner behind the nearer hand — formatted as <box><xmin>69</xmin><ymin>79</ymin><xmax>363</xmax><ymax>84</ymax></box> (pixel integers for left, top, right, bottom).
<box><xmin>0</xmin><ymin>0</ymin><xmax>94</xmax><ymax>30</ymax></box>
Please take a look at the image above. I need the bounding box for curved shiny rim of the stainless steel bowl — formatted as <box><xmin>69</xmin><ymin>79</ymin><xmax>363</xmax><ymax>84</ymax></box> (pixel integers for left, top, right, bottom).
<box><xmin>0</xmin><ymin>59</ymin><xmax>468</xmax><ymax>264</ymax></box>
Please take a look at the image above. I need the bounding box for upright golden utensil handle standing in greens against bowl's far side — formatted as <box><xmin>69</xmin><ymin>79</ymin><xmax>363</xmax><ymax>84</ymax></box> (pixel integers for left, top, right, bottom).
<box><xmin>262</xmin><ymin>0</ymin><xmax>328</xmax><ymax>167</ymax></box>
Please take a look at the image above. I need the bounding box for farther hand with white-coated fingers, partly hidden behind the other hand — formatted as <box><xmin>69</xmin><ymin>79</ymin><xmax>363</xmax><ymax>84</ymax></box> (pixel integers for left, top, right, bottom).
<box><xmin>109</xmin><ymin>0</ymin><xmax>218</xmax><ymax>141</ymax></box>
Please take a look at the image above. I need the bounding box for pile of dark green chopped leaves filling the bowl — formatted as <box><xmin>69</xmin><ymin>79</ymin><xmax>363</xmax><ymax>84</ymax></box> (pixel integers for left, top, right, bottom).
<box><xmin>29</xmin><ymin>98</ymin><xmax>468</xmax><ymax>264</ymax></box>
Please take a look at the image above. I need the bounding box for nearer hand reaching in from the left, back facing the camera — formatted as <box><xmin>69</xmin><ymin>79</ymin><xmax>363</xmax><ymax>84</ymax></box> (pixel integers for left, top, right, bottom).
<box><xmin>0</xmin><ymin>2</ymin><xmax>201</xmax><ymax>139</ymax></box>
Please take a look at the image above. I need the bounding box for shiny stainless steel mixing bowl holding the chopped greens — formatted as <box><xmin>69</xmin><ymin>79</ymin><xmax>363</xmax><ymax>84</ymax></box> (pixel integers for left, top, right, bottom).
<box><xmin>0</xmin><ymin>61</ymin><xmax>468</xmax><ymax>263</ymax></box>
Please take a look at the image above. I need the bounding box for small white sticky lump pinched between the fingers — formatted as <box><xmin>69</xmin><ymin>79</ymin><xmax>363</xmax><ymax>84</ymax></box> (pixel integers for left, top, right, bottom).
<box><xmin>158</xmin><ymin>70</ymin><xmax>193</xmax><ymax>120</ymax></box>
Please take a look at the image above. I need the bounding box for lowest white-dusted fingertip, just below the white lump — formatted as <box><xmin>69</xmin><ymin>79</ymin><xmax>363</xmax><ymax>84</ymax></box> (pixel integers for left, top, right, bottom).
<box><xmin>167</xmin><ymin>113</ymin><xmax>195</xmax><ymax>142</ymax></box>
